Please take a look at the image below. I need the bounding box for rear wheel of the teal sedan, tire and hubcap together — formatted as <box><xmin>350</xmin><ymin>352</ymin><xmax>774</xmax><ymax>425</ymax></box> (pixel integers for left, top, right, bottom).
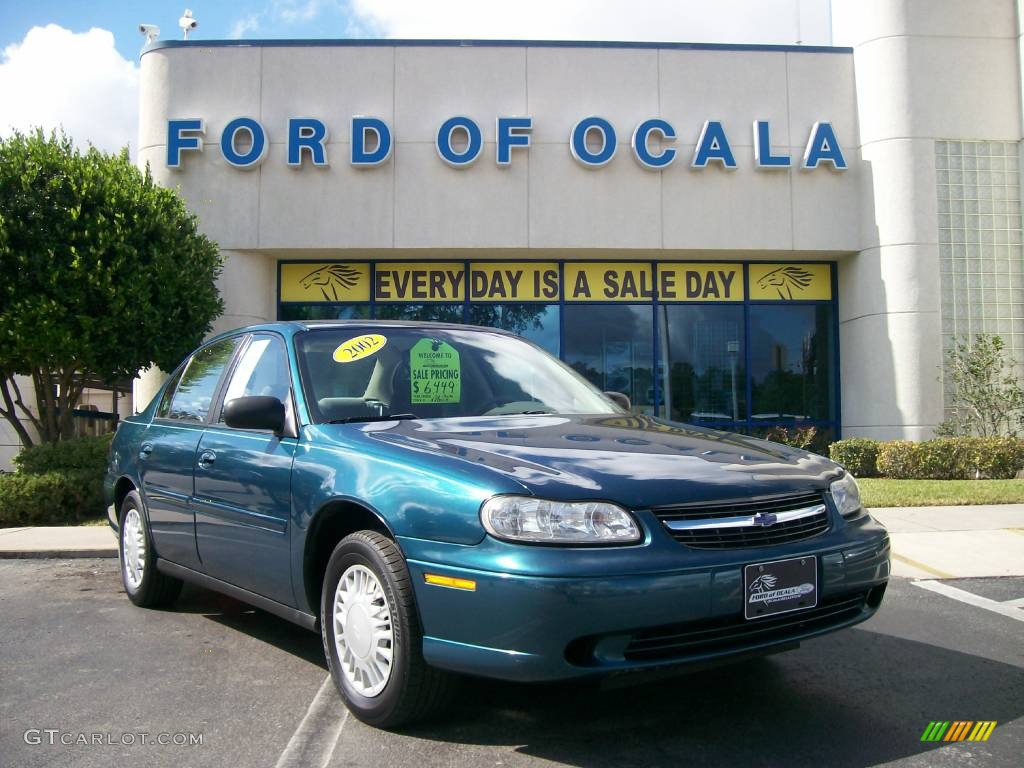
<box><xmin>118</xmin><ymin>490</ymin><xmax>181</xmax><ymax>608</ymax></box>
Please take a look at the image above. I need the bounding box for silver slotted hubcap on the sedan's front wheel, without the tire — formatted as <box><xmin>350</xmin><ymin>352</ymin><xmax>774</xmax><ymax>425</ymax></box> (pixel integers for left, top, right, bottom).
<box><xmin>334</xmin><ymin>565</ymin><xmax>394</xmax><ymax>698</ymax></box>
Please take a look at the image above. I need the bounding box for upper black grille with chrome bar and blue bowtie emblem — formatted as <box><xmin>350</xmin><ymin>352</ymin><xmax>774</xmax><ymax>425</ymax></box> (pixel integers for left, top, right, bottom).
<box><xmin>653</xmin><ymin>493</ymin><xmax>828</xmax><ymax>549</ymax></box>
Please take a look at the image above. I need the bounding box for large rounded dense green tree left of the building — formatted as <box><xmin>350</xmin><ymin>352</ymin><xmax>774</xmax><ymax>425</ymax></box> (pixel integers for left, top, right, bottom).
<box><xmin>0</xmin><ymin>130</ymin><xmax>223</xmax><ymax>446</ymax></box>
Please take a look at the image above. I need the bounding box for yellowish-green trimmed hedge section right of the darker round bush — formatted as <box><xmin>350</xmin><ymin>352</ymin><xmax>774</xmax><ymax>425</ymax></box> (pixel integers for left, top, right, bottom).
<box><xmin>878</xmin><ymin>437</ymin><xmax>1024</xmax><ymax>480</ymax></box>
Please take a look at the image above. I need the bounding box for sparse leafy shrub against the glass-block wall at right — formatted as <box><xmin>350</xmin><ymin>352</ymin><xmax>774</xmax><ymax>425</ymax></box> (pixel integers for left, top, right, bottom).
<box><xmin>936</xmin><ymin>334</ymin><xmax>1024</xmax><ymax>437</ymax></box>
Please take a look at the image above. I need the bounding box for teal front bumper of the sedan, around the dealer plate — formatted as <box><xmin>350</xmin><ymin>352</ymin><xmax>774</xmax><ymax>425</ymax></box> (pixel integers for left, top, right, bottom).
<box><xmin>399</xmin><ymin>515</ymin><xmax>889</xmax><ymax>682</ymax></box>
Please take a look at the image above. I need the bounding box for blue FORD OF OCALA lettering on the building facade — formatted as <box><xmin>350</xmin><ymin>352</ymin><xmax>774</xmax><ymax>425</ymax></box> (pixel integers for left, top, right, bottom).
<box><xmin>167</xmin><ymin>116</ymin><xmax>847</xmax><ymax>171</ymax></box>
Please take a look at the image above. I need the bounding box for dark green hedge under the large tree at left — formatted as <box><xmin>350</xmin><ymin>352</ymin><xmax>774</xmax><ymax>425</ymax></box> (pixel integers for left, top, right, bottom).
<box><xmin>0</xmin><ymin>435</ymin><xmax>112</xmax><ymax>527</ymax></box>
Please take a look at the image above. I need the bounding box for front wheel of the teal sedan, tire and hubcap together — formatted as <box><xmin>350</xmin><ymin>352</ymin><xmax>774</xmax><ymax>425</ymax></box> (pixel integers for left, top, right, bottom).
<box><xmin>321</xmin><ymin>530</ymin><xmax>455</xmax><ymax>728</ymax></box>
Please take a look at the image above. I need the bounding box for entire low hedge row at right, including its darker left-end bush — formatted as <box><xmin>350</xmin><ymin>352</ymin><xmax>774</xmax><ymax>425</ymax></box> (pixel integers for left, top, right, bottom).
<box><xmin>828</xmin><ymin>437</ymin><xmax>1024</xmax><ymax>480</ymax></box>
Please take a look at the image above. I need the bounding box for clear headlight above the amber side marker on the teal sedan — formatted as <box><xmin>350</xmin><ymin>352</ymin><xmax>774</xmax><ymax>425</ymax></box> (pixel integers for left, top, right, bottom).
<box><xmin>480</xmin><ymin>496</ymin><xmax>640</xmax><ymax>545</ymax></box>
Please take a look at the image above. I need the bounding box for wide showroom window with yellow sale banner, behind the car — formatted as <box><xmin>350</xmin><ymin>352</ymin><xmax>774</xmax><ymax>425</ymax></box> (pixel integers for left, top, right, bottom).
<box><xmin>278</xmin><ymin>260</ymin><xmax>840</xmax><ymax>438</ymax></box>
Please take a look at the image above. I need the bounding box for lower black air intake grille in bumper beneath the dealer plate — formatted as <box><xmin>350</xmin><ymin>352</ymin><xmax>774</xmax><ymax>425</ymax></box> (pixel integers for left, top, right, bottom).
<box><xmin>625</xmin><ymin>592</ymin><xmax>868</xmax><ymax>662</ymax></box>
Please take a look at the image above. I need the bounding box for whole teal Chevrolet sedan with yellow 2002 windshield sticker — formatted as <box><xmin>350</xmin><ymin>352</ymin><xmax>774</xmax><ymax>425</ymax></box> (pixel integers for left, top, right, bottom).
<box><xmin>105</xmin><ymin>322</ymin><xmax>889</xmax><ymax>727</ymax></box>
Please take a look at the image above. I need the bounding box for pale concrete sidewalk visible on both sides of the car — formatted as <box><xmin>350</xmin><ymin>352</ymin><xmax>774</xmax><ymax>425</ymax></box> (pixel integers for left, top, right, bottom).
<box><xmin>0</xmin><ymin>504</ymin><xmax>1024</xmax><ymax>579</ymax></box>
